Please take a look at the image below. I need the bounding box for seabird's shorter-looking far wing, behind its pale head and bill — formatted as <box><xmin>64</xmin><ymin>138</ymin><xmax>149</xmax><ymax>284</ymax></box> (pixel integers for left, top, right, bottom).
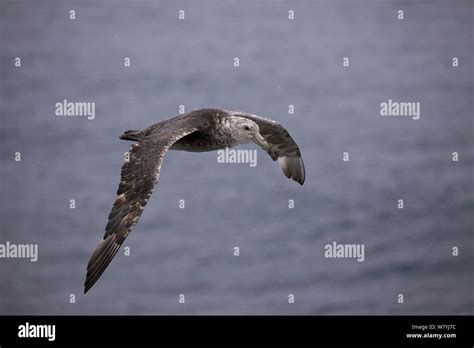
<box><xmin>239</xmin><ymin>114</ymin><xmax>305</xmax><ymax>185</ymax></box>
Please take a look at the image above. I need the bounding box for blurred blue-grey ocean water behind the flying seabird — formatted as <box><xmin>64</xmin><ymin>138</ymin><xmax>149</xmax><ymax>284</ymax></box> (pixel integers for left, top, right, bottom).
<box><xmin>0</xmin><ymin>0</ymin><xmax>474</xmax><ymax>314</ymax></box>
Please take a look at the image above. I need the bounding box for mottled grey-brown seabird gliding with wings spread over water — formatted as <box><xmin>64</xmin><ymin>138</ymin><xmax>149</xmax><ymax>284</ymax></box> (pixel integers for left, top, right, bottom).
<box><xmin>84</xmin><ymin>108</ymin><xmax>305</xmax><ymax>294</ymax></box>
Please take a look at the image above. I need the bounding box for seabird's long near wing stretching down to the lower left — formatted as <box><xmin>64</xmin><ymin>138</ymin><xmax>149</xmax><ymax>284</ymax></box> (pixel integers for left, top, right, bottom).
<box><xmin>84</xmin><ymin>118</ymin><xmax>200</xmax><ymax>293</ymax></box>
